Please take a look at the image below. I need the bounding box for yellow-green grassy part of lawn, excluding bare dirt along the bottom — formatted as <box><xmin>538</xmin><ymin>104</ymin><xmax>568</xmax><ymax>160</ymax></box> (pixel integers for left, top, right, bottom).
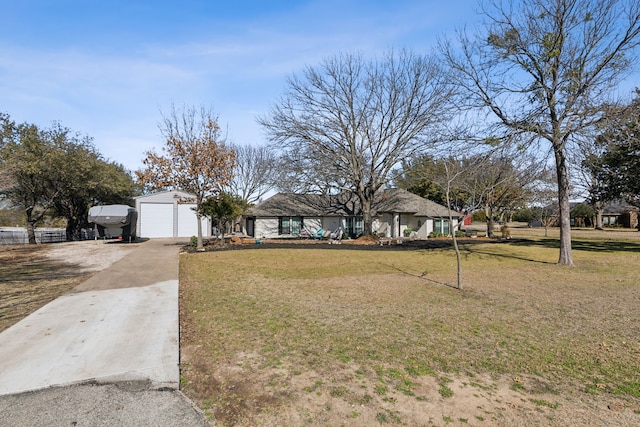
<box><xmin>180</xmin><ymin>238</ymin><xmax>640</xmax><ymax>423</ymax></box>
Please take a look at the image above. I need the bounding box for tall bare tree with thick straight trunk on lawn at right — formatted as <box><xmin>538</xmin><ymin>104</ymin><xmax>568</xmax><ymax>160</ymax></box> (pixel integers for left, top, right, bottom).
<box><xmin>442</xmin><ymin>0</ymin><xmax>640</xmax><ymax>265</ymax></box>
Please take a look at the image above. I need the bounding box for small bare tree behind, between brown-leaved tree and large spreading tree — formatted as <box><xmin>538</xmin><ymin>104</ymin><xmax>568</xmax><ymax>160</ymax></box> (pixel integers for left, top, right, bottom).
<box><xmin>227</xmin><ymin>145</ymin><xmax>278</xmax><ymax>204</ymax></box>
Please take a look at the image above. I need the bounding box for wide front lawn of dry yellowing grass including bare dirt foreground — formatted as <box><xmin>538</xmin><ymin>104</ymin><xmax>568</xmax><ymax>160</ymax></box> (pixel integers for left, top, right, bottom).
<box><xmin>180</xmin><ymin>238</ymin><xmax>640</xmax><ymax>426</ymax></box>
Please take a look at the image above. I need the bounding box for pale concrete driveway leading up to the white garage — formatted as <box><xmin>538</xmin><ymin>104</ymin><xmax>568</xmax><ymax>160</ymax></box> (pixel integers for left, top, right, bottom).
<box><xmin>0</xmin><ymin>239</ymin><xmax>206</xmax><ymax>426</ymax></box>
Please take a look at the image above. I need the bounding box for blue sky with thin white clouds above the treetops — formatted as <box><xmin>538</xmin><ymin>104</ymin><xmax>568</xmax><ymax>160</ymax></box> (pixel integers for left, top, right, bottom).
<box><xmin>0</xmin><ymin>0</ymin><xmax>480</xmax><ymax>170</ymax></box>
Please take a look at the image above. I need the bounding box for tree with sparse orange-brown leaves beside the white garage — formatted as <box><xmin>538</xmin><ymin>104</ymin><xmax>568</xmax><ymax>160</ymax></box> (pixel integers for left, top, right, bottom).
<box><xmin>136</xmin><ymin>105</ymin><xmax>235</xmax><ymax>250</ymax></box>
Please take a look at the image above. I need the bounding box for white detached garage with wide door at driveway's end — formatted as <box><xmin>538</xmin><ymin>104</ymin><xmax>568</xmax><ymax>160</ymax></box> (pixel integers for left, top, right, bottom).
<box><xmin>135</xmin><ymin>190</ymin><xmax>211</xmax><ymax>238</ymax></box>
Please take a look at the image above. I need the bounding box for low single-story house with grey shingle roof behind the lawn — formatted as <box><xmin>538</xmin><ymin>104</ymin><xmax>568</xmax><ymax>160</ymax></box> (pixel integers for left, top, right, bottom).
<box><xmin>245</xmin><ymin>188</ymin><xmax>462</xmax><ymax>238</ymax></box>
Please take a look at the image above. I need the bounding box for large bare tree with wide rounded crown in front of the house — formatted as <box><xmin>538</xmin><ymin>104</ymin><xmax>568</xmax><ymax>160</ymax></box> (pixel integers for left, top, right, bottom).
<box><xmin>259</xmin><ymin>51</ymin><xmax>450</xmax><ymax>234</ymax></box>
